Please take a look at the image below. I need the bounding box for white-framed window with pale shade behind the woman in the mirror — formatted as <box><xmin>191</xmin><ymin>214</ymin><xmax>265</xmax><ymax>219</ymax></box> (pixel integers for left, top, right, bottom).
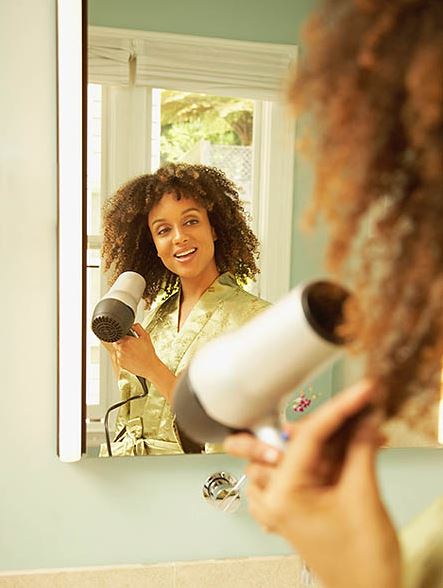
<box><xmin>87</xmin><ymin>27</ymin><xmax>295</xmax><ymax>445</ymax></box>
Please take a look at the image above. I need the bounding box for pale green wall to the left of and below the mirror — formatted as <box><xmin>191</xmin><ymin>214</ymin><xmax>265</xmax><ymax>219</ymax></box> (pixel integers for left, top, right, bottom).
<box><xmin>0</xmin><ymin>0</ymin><xmax>443</xmax><ymax>570</ymax></box>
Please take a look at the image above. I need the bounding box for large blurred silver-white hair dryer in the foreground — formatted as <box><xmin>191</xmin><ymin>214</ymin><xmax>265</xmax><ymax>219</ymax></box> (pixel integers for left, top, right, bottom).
<box><xmin>173</xmin><ymin>281</ymin><xmax>350</xmax><ymax>445</ymax></box>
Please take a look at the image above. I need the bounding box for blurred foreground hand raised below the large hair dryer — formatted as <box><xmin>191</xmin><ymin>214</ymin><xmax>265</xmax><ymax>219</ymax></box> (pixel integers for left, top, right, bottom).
<box><xmin>225</xmin><ymin>382</ymin><xmax>401</xmax><ymax>588</ymax></box>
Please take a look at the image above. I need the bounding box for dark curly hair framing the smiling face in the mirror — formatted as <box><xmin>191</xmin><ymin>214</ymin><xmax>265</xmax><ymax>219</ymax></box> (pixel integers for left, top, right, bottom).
<box><xmin>102</xmin><ymin>163</ymin><xmax>259</xmax><ymax>306</ymax></box>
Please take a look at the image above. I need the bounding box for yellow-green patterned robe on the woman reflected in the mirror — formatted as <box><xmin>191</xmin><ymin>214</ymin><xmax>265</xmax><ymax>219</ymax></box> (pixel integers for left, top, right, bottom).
<box><xmin>100</xmin><ymin>273</ymin><xmax>269</xmax><ymax>455</ymax></box>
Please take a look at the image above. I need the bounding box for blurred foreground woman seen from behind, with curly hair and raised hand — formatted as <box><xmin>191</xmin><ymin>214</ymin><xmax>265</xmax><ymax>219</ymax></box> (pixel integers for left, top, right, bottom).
<box><xmin>226</xmin><ymin>0</ymin><xmax>443</xmax><ymax>588</ymax></box>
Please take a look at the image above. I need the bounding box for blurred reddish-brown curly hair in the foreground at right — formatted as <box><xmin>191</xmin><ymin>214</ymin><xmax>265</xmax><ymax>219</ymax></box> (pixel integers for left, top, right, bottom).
<box><xmin>289</xmin><ymin>0</ymin><xmax>443</xmax><ymax>422</ymax></box>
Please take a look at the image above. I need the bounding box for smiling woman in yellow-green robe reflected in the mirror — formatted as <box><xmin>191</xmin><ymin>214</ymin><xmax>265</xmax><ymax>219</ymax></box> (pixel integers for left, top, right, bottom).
<box><xmin>102</xmin><ymin>164</ymin><xmax>268</xmax><ymax>455</ymax></box>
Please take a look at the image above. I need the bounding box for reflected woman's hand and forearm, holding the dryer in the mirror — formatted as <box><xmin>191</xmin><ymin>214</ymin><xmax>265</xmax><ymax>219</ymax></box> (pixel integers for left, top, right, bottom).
<box><xmin>112</xmin><ymin>323</ymin><xmax>177</xmax><ymax>404</ymax></box>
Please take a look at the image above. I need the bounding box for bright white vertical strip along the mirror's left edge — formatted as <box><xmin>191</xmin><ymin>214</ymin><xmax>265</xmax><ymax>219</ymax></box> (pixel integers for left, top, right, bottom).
<box><xmin>57</xmin><ymin>0</ymin><xmax>85</xmax><ymax>462</ymax></box>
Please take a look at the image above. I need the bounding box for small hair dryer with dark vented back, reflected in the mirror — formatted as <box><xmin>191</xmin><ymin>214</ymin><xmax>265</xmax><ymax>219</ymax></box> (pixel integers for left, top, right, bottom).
<box><xmin>91</xmin><ymin>272</ymin><xmax>146</xmax><ymax>343</ymax></box>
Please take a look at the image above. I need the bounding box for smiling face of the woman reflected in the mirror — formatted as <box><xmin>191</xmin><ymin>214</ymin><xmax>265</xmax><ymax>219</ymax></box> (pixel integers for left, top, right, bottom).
<box><xmin>148</xmin><ymin>192</ymin><xmax>218</xmax><ymax>279</ymax></box>
